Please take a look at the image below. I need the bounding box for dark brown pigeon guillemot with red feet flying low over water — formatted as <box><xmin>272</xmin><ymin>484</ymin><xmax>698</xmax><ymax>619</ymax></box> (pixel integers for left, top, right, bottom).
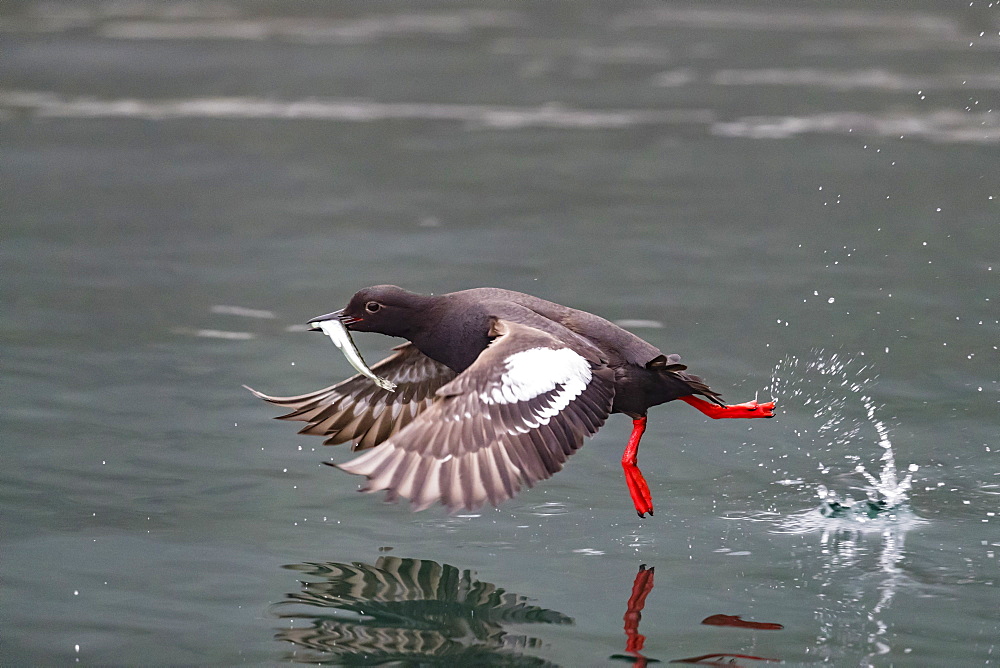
<box><xmin>247</xmin><ymin>285</ymin><xmax>774</xmax><ymax>517</ymax></box>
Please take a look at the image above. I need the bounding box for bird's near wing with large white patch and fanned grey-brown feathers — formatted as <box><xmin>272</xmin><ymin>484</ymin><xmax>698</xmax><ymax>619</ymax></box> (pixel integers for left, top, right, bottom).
<box><xmin>338</xmin><ymin>319</ymin><xmax>614</xmax><ymax>511</ymax></box>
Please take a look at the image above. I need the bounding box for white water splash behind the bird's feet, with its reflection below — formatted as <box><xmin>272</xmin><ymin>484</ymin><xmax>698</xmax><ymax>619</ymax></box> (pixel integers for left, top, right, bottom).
<box><xmin>753</xmin><ymin>350</ymin><xmax>925</xmax><ymax>665</ymax></box>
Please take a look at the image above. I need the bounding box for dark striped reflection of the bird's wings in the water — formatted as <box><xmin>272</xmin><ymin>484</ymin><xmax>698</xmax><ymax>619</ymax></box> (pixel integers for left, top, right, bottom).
<box><xmin>274</xmin><ymin>556</ymin><xmax>573</xmax><ymax>666</ymax></box>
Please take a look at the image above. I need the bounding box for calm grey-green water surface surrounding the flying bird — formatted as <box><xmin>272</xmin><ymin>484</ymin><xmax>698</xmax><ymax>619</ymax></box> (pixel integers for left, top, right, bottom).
<box><xmin>0</xmin><ymin>0</ymin><xmax>1000</xmax><ymax>666</ymax></box>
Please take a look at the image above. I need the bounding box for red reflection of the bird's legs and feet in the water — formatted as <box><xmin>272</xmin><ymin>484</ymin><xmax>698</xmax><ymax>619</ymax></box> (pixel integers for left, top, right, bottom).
<box><xmin>611</xmin><ymin>564</ymin><xmax>784</xmax><ymax>668</ymax></box>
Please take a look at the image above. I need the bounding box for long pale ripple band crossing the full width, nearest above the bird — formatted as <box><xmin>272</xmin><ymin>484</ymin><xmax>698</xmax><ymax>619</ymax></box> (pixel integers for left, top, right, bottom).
<box><xmin>0</xmin><ymin>88</ymin><xmax>1000</xmax><ymax>144</ymax></box>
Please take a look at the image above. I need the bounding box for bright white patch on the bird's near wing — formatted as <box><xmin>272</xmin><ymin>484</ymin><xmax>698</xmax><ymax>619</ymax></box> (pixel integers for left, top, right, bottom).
<box><xmin>479</xmin><ymin>348</ymin><xmax>592</xmax><ymax>429</ymax></box>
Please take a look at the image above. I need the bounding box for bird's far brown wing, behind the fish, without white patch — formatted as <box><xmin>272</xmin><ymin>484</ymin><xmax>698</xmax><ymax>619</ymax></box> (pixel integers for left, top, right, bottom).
<box><xmin>244</xmin><ymin>343</ymin><xmax>455</xmax><ymax>450</ymax></box>
